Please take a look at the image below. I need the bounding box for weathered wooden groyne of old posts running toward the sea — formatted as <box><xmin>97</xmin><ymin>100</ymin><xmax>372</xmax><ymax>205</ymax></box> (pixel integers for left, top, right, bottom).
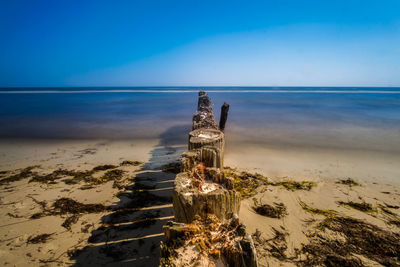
<box><xmin>160</xmin><ymin>91</ymin><xmax>258</xmax><ymax>267</ymax></box>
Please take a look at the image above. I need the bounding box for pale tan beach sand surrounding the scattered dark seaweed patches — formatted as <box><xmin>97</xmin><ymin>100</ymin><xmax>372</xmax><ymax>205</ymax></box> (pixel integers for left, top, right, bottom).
<box><xmin>0</xmin><ymin>139</ymin><xmax>400</xmax><ymax>266</ymax></box>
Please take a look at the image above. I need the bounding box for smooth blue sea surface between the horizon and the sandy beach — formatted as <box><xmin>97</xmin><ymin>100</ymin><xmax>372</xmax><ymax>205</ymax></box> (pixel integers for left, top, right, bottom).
<box><xmin>0</xmin><ymin>87</ymin><xmax>400</xmax><ymax>153</ymax></box>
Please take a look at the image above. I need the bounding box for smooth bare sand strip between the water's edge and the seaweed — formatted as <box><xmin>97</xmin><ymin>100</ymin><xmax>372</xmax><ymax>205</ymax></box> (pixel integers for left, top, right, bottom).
<box><xmin>0</xmin><ymin>137</ymin><xmax>400</xmax><ymax>185</ymax></box>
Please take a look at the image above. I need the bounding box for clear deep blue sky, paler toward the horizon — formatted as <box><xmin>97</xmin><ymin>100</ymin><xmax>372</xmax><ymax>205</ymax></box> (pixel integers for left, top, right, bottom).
<box><xmin>0</xmin><ymin>0</ymin><xmax>400</xmax><ymax>87</ymax></box>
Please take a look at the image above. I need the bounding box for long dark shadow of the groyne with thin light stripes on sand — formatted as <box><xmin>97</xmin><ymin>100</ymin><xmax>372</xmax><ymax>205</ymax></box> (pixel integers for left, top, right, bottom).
<box><xmin>71</xmin><ymin>125</ymin><xmax>190</xmax><ymax>267</ymax></box>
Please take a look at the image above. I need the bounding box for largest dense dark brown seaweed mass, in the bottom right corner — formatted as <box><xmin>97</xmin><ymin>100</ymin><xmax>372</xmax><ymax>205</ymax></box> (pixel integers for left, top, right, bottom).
<box><xmin>301</xmin><ymin>216</ymin><xmax>400</xmax><ymax>266</ymax></box>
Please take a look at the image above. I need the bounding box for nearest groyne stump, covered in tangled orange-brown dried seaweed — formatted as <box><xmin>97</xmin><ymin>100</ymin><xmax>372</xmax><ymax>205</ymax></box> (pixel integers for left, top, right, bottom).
<box><xmin>160</xmin><ymin>214</ymin><xmax>255</xmax><ymax>266</ymax></box>
